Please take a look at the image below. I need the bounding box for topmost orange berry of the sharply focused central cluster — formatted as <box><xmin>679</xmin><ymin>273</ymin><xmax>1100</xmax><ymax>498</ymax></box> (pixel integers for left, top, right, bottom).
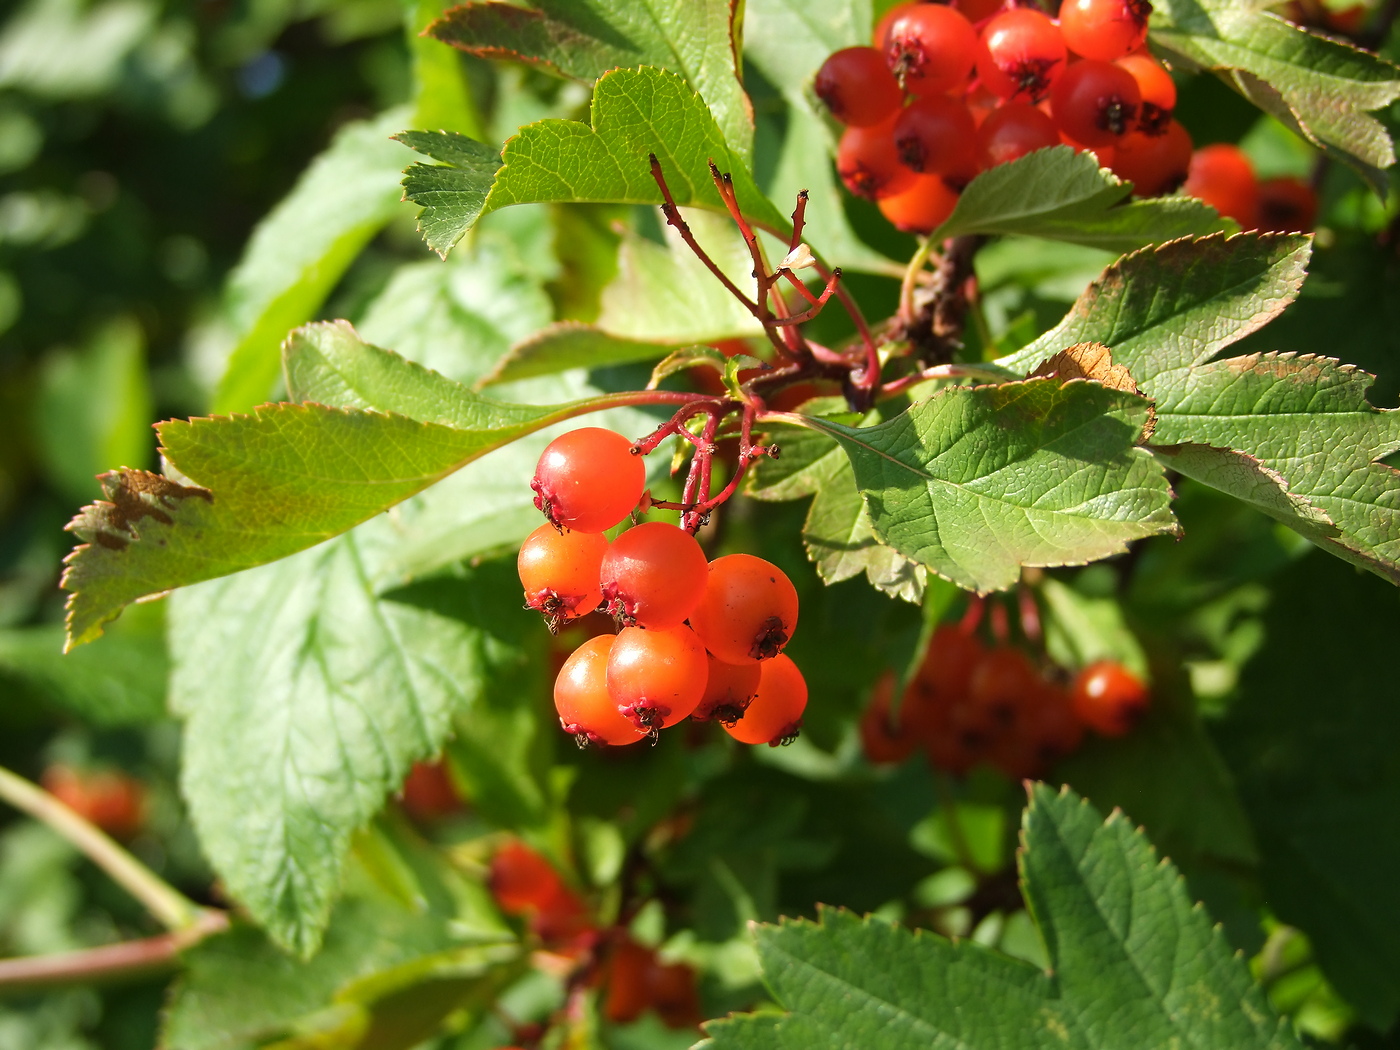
<box><xmin>531</xmin><ymin>427</ymin><xmax>647</xmax><ymax>532</ymax></box>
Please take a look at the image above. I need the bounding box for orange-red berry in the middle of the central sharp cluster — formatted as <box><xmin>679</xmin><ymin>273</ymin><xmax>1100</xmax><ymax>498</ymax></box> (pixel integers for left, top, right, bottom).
<box><xmin>598</xmin><ymin>521</ymin><xmax>710</xmax><ymax>629</ymax></box>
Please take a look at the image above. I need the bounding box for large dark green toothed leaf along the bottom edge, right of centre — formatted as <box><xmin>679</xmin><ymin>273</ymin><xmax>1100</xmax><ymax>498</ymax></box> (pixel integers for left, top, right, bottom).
<box><xmin>704</xmin><ymin>784</ymin><xmax>1299</xmax><ymax>1050</ymax></box>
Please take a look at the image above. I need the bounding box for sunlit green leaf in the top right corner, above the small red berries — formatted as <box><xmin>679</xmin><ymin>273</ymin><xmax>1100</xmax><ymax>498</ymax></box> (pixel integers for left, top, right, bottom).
<box><xmin>1152</xmin><ymin>0</ymin><xmax>1400</xmax><ymax>195</ymax></box>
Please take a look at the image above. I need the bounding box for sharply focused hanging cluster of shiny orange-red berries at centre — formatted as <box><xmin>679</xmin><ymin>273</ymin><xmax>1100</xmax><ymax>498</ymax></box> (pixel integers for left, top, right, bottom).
<box><xmin>518</xmin><ymin>427</ymin><xmax>806</xmax><ymax>745</ymax></box>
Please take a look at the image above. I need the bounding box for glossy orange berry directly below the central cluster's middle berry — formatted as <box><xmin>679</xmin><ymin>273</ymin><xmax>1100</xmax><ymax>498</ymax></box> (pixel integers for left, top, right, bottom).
<box><xmin>608</xmin><ymin>626</ymin><xmax>710</xmax><ymax>731</ymax></box>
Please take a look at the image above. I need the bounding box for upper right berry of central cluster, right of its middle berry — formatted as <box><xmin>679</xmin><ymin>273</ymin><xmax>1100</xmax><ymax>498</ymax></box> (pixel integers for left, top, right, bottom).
<box><xmin>690</xmin><ymin>554</ymin><xmax>797</xmax><ymax>664</ymax></box>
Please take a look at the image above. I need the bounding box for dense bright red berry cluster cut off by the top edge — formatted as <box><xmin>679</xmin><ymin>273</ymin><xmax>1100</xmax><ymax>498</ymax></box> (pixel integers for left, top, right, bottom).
<box><xmin>815</xmin><ymin>0</ymin><xmax>1316</xmax><ymax>234</ymax></box>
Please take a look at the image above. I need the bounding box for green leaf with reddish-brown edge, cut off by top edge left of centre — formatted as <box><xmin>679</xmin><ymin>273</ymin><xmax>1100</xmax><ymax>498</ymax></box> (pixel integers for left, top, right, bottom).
<box><xmin>428</xmin><ymin>0</ymin><xmax>753</xmax><ymax>157</ymax></box>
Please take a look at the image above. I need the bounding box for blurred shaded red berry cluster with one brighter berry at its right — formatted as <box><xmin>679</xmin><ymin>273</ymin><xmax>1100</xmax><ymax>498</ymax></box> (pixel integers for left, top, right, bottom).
<box><xmin>860</xmin><ymin>626</ymin><xmax>1148</xmax><ymax>780</ymax></box>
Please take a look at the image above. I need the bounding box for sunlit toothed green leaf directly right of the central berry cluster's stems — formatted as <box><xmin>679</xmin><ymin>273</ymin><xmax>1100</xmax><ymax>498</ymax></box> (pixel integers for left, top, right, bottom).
<box><xmin>808</xmin><ymin>379</ymin><xmax>1176</xmax><ymax>592</ymax></box>
